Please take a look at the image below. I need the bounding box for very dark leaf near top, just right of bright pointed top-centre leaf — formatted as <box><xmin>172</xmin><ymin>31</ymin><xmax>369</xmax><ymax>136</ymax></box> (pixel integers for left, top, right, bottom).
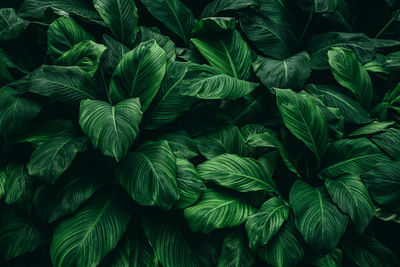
<box><xmin>240</xmin><ymin>11</ymin><xmax>297</xmax><ymax>60</ymax></box>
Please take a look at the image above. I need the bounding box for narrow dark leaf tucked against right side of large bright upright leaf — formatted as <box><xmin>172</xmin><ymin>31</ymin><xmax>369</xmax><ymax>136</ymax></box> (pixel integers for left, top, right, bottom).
<box><xmin>144</xmin><ymin>61</ymin><xmax>193</xmax><ymax>130</ymax></box>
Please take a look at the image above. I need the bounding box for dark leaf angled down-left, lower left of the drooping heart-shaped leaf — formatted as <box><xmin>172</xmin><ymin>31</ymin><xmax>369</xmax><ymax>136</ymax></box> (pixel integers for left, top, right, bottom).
<box><xmin>26</xmin><ymin>130</ymin><xmax>87</xmax><ymax>184</ymax></box>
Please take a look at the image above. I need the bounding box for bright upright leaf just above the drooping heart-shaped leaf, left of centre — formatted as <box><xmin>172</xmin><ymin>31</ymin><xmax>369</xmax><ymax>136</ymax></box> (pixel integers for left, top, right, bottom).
<box><xmin>109</xmin><ymin>40</ymin><xmax>166</xmax><ymax>111</ymax></box>
